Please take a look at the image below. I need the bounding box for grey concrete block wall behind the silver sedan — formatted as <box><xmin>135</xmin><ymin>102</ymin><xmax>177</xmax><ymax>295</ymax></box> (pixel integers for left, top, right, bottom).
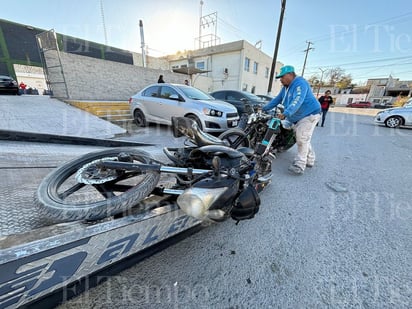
<box><xmin>45</xmin><ymin>50</ymin><xmax>189</xmax><ymax>101</ymax></box>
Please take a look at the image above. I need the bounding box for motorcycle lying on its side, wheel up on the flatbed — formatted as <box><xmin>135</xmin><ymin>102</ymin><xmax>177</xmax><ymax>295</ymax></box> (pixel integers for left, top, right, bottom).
<box><xmin>35</xmin><ymin>117</ymin><xmax>272</xmax><ymax>222</ymax></box>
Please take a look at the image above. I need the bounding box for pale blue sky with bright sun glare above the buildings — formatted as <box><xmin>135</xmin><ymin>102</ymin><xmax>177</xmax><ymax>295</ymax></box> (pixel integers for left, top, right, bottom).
<box><xmin>0</xmin><ymin>0</ymin><xmax>412</xmax><ymax>84</ymax></box>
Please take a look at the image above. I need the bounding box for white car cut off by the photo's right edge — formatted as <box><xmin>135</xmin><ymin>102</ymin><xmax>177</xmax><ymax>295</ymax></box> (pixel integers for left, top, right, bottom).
<box><xmin>375</xmin><ymin>98</ymin><xmax>412</xmax><ymax>128</ymax></box>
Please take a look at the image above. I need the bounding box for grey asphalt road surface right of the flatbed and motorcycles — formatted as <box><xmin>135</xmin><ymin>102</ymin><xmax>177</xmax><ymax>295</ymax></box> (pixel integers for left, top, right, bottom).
<box><xmin>58</xmin><ymin>109</ymin><xmax>412</xmax><ymax>309</ymax></box>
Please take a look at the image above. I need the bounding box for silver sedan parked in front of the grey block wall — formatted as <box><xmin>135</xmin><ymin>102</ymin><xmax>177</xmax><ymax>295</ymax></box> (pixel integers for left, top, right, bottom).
<box><xmin>129</xmin><ymin>83</ymin><xmax>239</xmax><ymax>133</ymax></box>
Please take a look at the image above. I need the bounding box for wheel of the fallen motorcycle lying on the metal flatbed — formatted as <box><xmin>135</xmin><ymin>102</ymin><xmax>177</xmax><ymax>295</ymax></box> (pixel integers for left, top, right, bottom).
<box><xmin>35</xmin><ymin>147</ymin><xmax>160</xmax><ymax>222</ymax></box>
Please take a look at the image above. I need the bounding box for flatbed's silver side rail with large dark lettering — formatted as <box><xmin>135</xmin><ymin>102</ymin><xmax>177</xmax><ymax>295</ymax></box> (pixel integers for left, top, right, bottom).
<box><xmin>0</xmin><ymin>199</ymin><xmax>199</xmax><ymax>308</ymax></box>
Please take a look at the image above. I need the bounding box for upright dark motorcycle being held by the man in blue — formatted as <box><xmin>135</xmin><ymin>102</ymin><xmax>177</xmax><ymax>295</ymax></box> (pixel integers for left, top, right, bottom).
<box><xmin>219</xmin><ymin>107</ymin><xmax>296</xmax><ymax>156</ymax></box>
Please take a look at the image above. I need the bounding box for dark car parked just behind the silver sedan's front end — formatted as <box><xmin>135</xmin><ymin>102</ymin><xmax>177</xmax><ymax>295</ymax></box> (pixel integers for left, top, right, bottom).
<box><xmin>210</xmin><ymin>90</ymin><xmax>264</xmax><ymax>115</ymax></box>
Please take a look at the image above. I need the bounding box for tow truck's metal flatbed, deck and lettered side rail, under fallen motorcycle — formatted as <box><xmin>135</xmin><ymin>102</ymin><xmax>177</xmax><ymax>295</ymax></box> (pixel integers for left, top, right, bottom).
<box><xmin>0</xmin><ymin>137</ymin><xmax>200</xmax><ymax>309</ymax></box>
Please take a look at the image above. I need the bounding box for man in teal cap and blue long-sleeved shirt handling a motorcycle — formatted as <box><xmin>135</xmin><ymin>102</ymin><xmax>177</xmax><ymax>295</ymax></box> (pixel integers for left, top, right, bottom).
<box><xmin>263</xmin><ymin>65</ymin><xmax>321</xmax><ymax>175</ymax></box>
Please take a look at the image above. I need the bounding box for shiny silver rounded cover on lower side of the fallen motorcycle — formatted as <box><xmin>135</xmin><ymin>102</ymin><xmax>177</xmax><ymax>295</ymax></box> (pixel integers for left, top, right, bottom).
<box><xmin>177</xmin><ymin>187</ymin><xmax>227</xmax><ymax>220</ymax></box>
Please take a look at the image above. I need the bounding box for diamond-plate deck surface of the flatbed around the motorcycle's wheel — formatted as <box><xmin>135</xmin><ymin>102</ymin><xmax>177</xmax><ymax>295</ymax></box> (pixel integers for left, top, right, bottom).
<box><xmin>0</xmin><ymin>141</ymin><xmax>170</xmax><ymax>237</ymax></box>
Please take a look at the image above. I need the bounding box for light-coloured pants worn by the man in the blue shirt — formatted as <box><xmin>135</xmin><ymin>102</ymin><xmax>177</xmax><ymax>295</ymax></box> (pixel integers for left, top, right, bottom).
<box><xmin>293</xmin><ymin>114</ymin><xmax>320</xmax><ymax>171</ymax></box>
